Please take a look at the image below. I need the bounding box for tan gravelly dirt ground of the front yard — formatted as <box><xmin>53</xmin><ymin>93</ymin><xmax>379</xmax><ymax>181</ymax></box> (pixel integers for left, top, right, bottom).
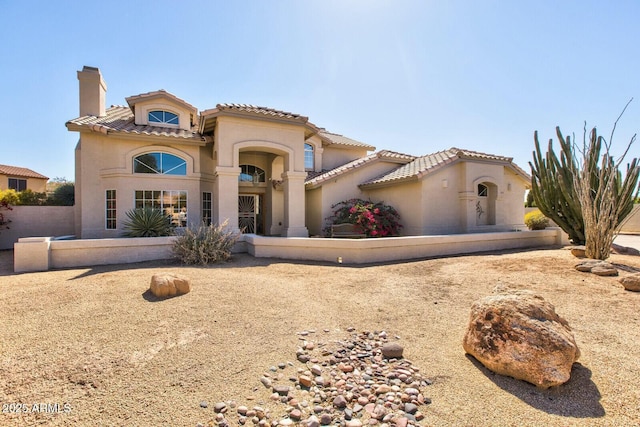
<box><xmin>0</xmin><ymin>249</ymin><xmax>640</xmax><ymax>426</ymax></box>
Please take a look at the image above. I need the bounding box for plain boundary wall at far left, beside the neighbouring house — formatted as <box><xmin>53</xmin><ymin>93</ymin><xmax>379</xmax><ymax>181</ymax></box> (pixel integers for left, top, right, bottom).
<box><xmin>0</xmin><ymin>206</ymin><xmax>74</xmax><ymax>249</ymax></box>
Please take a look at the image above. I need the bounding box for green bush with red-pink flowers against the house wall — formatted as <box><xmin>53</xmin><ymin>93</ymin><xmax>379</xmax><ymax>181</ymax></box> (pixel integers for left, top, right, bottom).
<box><xmin>324</xmin><ymin>199</ymin><xmax>402</xmax><ymax>237</ymax></box>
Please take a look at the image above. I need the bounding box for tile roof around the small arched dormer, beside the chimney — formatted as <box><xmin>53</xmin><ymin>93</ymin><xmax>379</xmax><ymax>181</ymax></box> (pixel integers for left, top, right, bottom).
<box><xmin>67</xmin><ymin>105</ymin><xmax>205</xmax><ymax>142</ymax></box>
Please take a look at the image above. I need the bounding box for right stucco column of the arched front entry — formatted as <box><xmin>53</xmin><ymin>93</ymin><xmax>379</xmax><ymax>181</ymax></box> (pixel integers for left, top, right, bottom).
<box><xmin>282</xmin><ymin>171</ymin><xmax>309</xmax><ymax>237</ymax></box>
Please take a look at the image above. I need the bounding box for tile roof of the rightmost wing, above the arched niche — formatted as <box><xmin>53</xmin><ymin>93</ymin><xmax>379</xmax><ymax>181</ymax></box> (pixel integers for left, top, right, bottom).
<box><xmin>360</xmin><ymin>147</ymin><xmax>531</xmax><ymax>187</ymax></box>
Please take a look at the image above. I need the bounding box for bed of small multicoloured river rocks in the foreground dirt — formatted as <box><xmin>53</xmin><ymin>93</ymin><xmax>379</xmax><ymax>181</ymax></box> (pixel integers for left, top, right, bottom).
<box><xmin>197</xmin><ymin>328</ymin><xmax>431</xmax><ymax>427</ymax></box>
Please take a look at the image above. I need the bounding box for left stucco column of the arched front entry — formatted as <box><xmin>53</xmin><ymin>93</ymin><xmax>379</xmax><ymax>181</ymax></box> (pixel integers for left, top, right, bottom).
<box><xmin>213</xmin><ymin>166</ymin><xmax>240</xmax><ymax>232</ymax></box>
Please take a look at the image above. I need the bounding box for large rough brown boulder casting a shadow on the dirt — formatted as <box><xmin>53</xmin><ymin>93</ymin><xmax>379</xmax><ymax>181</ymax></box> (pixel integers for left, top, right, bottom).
<box><xmin>463</xmin><ymin>290</ymin><xmax>580</xmax><ymax>388</ymax></box>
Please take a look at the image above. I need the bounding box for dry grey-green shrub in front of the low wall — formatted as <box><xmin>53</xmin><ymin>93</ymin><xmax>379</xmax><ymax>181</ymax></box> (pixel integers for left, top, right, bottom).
<box><xmin>173</xmin><ymin>221</ymin><xmax>240</xmax><ymax>265</ymax></box>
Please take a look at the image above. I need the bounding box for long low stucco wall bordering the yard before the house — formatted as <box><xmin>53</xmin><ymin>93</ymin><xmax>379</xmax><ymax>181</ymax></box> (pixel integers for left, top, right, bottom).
<box><xmin>14</xmin><ymin>228</ymin><xmax>568</xmax><ymax>273</ymax></box>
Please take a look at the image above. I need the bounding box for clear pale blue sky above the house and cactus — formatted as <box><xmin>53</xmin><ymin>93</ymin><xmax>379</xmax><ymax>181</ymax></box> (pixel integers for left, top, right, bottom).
<box><xmin>0</xmin><ymin>0</ymin><xmax>640</xmax><ymax>180</ymax></box>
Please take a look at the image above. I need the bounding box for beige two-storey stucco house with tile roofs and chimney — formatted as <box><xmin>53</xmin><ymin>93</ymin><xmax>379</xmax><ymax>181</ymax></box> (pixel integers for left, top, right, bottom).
<box><xmin>66</xmin><ymin>66</ymin><xmax>530</xmax><ymax>238</ymax></box>
